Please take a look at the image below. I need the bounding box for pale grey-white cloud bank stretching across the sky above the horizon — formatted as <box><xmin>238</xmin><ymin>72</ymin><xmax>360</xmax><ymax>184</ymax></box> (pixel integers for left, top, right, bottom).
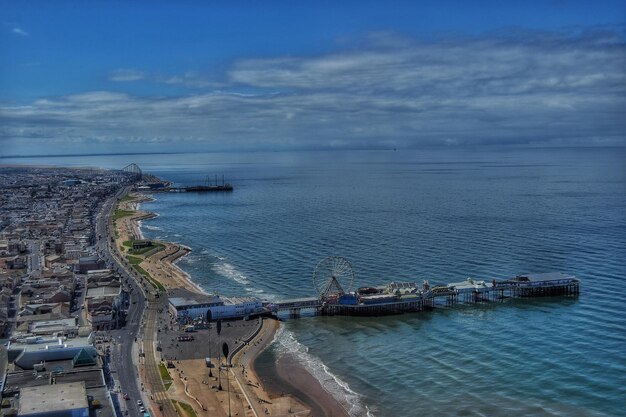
<box><xmin>0</xmin><ymin>28</ymin><xmax>626</xmax><ymax>151</ymax></box>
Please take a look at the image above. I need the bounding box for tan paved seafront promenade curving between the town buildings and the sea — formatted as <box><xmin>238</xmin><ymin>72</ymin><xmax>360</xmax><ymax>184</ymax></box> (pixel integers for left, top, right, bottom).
<box><xmin>107</xmin><ymin>189</ymin><xmax>309</xmax><ymax>417</ymax></box>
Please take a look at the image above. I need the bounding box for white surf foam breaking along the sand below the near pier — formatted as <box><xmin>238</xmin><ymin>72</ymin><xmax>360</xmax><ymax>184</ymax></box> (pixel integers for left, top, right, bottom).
<box><xmin>275</xmin><ymin>326</ymin><xmax>373</xmax><ymax>417</ymax></box>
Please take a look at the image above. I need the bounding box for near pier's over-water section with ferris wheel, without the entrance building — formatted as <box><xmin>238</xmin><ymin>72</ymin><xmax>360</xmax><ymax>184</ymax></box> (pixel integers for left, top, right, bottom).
<box><xmin>265</xmin><ymin>257</ymin><xmax>580</xmax><ymax>318</ymax></box>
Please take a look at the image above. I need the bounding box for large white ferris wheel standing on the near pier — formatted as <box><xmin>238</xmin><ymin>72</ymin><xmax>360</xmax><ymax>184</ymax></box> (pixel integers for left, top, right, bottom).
<box><xmin>313</xmin><ymin>256</ymin><xmax>354</xmax><ymax>298</ymax></box>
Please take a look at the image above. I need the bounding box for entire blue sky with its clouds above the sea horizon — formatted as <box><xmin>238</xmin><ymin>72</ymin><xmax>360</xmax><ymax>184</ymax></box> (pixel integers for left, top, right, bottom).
<box><xmin>0</xmin><ymin>0</ymin><xmax>626</xmax><ymax>156</ymax></box>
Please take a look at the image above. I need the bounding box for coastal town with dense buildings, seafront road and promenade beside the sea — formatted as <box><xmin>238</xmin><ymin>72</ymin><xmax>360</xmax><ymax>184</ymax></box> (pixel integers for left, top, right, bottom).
<box><xmin>0</xmin><ymin>167</ymin><xmax>322</xmax><ymax>417</ymax></box>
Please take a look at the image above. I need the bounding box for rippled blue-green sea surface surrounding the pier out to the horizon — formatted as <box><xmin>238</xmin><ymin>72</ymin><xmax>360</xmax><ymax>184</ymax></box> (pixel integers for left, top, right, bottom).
<box><xmin>6</xmin><ymin>148</ymin><xmax>626</xmax><ymax>416</ymax></box>
